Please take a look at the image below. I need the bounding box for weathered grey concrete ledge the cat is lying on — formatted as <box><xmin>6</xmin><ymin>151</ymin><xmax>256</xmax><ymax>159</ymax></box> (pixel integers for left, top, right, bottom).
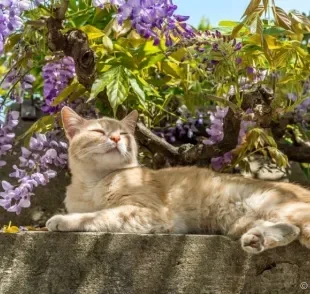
<box><xmin>0</xmin><ymin>232</ymin><xmax>310</xmax><ymax>294</ymax></box>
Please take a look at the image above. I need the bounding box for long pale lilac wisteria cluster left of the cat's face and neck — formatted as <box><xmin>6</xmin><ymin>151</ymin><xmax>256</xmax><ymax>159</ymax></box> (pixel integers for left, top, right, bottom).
<box><xmin>0</xmin><ymin>131</ymin><xmax>68</xmax><ymax>214</ymax></box>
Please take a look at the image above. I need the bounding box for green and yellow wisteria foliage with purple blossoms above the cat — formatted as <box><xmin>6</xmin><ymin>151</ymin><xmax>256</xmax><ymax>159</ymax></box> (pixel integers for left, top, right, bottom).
<box><xmin>0</xmin><ymin>0</ymin><xmax>310</xmax><ymax>213</ymax></box>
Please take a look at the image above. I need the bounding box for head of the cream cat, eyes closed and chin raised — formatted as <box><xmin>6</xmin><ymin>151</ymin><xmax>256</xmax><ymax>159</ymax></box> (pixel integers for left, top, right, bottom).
<box><xmin>61</xmin><ymin>106</ymin><xmax>138</xmax><ymax>169</ymax></box>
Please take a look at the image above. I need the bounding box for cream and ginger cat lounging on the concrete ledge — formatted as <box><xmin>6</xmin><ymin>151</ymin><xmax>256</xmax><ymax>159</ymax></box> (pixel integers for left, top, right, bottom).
<box><xmin>46</xmin><ymin>107</ymin><xmax>310</xmax><ymax>254</ymax></box>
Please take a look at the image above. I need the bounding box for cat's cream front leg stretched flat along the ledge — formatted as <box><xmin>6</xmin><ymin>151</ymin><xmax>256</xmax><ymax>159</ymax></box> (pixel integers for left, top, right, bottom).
<box><xmin>46</xmin><ymin>205</ymin><xmax>170</xmax><ymax>233</ymax></box>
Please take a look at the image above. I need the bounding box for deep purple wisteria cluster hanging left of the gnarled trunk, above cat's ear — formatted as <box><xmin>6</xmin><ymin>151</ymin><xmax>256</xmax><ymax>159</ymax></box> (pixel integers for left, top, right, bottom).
<box><xmin>42</xmin><ymin>56</ymin><xmax>75</xmax><ymax>114</ymax></box>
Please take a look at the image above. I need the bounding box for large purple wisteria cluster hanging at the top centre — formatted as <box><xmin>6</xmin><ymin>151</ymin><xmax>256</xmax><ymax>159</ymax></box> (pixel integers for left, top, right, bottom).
<box><xmin>93</xmin><ymin>0</ymin><xmax>195</xmax><ymax>46</ymax></box>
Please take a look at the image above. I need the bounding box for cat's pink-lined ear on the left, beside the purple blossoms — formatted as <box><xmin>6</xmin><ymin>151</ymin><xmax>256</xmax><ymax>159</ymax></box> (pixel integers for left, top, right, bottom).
<box><xmin>61</xmin><ymin>106</ymin><xmax>85</xmax><ymax>140</ymax></box>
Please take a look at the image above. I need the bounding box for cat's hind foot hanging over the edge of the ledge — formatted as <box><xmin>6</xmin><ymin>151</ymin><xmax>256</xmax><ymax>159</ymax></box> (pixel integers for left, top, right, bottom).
<box><xmin>241</xmin><ymin>221</ymin><xmax>300</xmax><ymax>254</ymax></box>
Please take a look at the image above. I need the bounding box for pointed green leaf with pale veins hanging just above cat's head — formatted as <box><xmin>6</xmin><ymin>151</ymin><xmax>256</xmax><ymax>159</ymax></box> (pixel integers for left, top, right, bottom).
<box><xmin>107</xmin><ymin>66</ymin><xmax>129</xmax><ymax>116</ymax></box>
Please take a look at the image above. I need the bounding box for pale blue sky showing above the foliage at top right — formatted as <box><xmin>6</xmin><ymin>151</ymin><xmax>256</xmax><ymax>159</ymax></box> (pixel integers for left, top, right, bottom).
<box><xmin>173</xmin><ymin>0</ymin><xmax>310</xmax><ymax>26</ymax></box>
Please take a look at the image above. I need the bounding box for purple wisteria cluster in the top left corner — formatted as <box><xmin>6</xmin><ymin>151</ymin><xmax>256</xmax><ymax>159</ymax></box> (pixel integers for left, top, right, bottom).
<box><xmin>0</xmin><ymin>0</ymin><xmax>39</xmax><ymax>55</ymax></box>
